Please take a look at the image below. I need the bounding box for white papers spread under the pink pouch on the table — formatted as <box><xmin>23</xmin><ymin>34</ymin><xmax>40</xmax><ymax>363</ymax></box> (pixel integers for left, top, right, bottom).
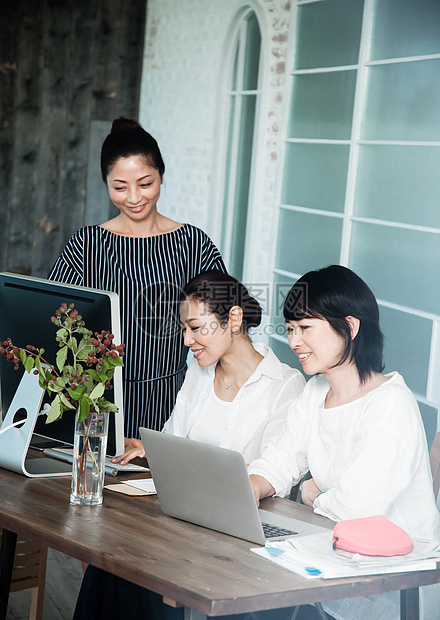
<box><xmin>251</xmin><ymin>531</ymin><xmax>440</xmax><ymax>579</ymax></box>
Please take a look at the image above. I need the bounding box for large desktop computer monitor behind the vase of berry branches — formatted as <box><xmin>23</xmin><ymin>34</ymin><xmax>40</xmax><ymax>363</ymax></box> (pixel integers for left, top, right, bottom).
<box><xmin>0</xmin><ymin>273</ymin><xmax>124</xmax><ymax>456</ymax></box>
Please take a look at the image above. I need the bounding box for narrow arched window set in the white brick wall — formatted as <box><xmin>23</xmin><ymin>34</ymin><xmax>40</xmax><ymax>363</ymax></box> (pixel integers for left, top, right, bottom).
<box><xmin>221</xmin><ymin>8</ymin><xmax>261</xmax><ymax>279</ymax></box>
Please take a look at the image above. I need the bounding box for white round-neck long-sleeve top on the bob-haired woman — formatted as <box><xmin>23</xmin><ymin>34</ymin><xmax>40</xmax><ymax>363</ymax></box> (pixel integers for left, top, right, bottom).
<box><xmin>249</xmin><ymin>372</ymin><xmax>440</xmax><ymax>620</ymax></box>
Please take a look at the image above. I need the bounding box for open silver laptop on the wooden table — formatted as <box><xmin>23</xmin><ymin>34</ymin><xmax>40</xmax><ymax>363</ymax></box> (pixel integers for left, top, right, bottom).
<box><xmin>140</xmin><ymin>428</ymin><xmax>328</xmax><ymax>545</ymax></box>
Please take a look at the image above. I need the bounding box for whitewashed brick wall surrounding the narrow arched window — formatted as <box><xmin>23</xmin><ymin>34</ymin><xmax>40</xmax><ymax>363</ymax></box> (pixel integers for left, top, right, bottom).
<box><xmin>140</xmin><ymin>0</ymin><xmax>290</xmax><ymax>282</ymax></box>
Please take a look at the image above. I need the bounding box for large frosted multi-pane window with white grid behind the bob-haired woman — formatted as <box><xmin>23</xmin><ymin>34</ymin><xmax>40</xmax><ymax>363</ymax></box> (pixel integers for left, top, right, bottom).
<box><xmin>271</xmin><ymin>0</ymin><xmax>440</xmax><ymax>446</ymax></box>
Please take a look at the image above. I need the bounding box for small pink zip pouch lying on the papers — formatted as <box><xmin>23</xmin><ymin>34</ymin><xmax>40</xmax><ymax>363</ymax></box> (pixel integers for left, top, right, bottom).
<box><xmin>333</xmin><ymin>515</ymin><xmax>413</xmax><ymax>556</ymax></box>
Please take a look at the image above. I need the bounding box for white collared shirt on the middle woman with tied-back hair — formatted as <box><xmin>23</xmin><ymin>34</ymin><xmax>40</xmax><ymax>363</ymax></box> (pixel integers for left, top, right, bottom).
<box><xmin>163</xmin><ymin>343</ymin><xmax>305</xmax><ymax>463</ymax></box>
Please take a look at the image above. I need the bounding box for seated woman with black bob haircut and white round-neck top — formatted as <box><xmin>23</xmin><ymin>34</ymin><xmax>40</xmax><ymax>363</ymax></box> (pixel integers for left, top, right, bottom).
<box><xmin>249</xmin><ymin>265</ymin><xmax>440</xmax><ymax>620</ymax></box>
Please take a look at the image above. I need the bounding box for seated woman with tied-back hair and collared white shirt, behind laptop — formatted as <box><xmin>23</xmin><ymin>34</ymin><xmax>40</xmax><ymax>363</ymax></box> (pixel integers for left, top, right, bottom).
<box><xmin>114</xmin><ymin>271</ymin><xmax>305</xmax><ymax>463</ymax></box>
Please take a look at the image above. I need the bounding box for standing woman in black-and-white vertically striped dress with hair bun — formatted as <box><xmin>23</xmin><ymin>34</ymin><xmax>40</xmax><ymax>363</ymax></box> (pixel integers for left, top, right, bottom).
<box><xmin>48</xmin><ymin>118</ymin><xmax>226</xmax><ymax>437</ymax></box>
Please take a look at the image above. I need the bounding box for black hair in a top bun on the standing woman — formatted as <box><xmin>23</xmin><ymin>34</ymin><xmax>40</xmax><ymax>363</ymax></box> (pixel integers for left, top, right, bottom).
<box><xmin>101</xmin><ymin>117</ymin><xmax>165</xmax><ymax>183</ymax></box>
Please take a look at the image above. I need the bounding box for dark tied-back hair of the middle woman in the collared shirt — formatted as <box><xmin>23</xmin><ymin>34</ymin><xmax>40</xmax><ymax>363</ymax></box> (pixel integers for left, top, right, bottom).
<box><xmin>181</xmin><ymin>270</ymin><xmax>262</xmax><ymax>332</ymax></box>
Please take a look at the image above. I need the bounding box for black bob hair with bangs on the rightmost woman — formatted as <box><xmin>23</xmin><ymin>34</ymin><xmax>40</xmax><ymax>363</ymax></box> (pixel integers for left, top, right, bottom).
<box><xmin>284</xmin><ymin>265</ymin><xmax>384</xmax><ymax>383</ymax></box>
